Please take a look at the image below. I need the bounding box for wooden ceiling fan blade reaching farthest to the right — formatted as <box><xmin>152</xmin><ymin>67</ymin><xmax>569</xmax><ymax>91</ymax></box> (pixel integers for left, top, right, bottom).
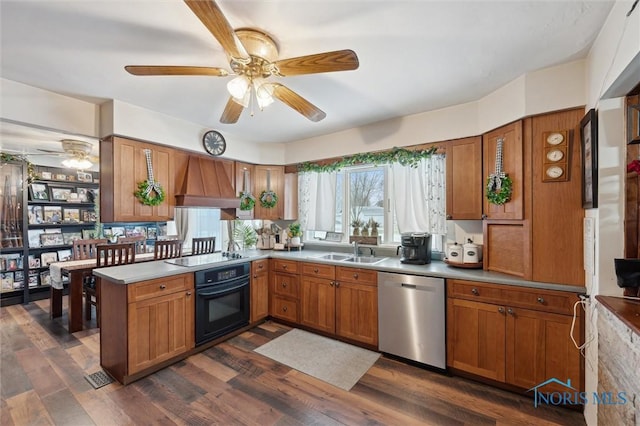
<box><xmin>273</xmin><ymin>49</ymin><xmax>360</xmax><ymax>76</ymax></box>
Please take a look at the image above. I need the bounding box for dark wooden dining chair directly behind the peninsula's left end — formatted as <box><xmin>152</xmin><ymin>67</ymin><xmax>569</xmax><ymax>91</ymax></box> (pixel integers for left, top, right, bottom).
<box><xmin>83</xmin><ymin>243</ymin><xmax>136</xmax><ymax>327</ymax></box>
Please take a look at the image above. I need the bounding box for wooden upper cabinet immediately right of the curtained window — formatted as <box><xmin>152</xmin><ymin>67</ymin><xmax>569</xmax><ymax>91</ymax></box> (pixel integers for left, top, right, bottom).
<box><xmin>446</xmin><ymin>136</ymin><xmax>483</xmax><ymax>220</ymax></box>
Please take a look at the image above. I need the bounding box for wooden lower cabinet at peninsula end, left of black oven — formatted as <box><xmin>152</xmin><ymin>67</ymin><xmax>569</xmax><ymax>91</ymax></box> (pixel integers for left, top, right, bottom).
<box><xmin>100</xmin><ymin>274</ymin><xmax>195</xmax><ymax>384</ymax></box>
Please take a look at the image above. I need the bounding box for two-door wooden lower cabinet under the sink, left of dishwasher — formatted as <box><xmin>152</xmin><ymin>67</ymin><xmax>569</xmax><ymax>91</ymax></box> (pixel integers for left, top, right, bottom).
<box><xmin>300</xmin><ymin>263</ymin><xmax>378</xmax><ymax>347</ymax></box>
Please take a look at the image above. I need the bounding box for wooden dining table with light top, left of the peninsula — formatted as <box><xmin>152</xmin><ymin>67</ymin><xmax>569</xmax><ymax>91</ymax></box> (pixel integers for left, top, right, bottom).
<box><xmin>49</xmin><ymin>253</ymin><xmax>154</xmax><ymax>333</ymax></box>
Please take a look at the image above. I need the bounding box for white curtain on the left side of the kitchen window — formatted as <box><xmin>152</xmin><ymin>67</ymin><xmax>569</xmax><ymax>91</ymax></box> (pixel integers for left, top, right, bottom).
<box><xmin>298</xmin><ymin>172</ymin><xmax>336</xmax><ymax>235</ymax></box>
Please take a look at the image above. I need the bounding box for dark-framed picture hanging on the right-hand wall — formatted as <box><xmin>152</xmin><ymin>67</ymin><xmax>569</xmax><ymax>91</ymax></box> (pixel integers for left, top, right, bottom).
<box><xmin>580</xmin><ymin>109</ymin><xmax>598</xmax><ymax>209</ymax></box>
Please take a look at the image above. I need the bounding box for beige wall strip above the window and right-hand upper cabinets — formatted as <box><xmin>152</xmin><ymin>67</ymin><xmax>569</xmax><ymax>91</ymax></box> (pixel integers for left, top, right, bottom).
<box><xmin>285</xmin><ymin>61</ymin><xmax>585</xmax><ymax>164</ymax></box>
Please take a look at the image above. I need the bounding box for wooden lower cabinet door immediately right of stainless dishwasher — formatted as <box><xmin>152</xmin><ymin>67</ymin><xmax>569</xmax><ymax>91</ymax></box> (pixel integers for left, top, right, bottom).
<box><xmin>447</xmin><ymin>298</ymin><xmax>505</xmax><ymax>382</ymax></box>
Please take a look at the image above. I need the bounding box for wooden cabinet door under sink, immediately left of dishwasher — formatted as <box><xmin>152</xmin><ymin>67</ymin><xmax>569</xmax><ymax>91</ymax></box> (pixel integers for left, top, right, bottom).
<box><xmin>336</xmin><ymin>282</ymin><xmax>378</xmax><ymax>348</ymax></box>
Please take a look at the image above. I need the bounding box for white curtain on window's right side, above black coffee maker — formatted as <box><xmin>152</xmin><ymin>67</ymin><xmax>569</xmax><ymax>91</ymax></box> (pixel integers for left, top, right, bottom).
<box><xmin>391</xmin><ymin>155</ymin><xmax>446</xmax><ymax>250</ymax></box>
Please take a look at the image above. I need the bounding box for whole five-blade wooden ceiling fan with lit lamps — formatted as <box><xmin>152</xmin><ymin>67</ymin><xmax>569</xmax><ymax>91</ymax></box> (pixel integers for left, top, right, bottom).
<box><xmin>125</xmin><ymin>0</ymin><xmax>359</xmax><ymax>123</ymax></box>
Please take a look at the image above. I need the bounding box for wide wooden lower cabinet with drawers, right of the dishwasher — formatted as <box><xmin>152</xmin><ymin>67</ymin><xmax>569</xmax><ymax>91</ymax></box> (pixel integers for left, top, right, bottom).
<box><xmin>447</xmin><ymin>280</ymin><xmax>584</xmax><ymax>391</ymax></box>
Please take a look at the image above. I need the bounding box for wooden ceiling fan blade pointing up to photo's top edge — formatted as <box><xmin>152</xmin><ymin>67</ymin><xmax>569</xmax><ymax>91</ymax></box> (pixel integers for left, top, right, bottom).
<box><xmin>184</xmin><ymin>0</ymin><xmax>250</xmax><ymax>61</ymax></box>
